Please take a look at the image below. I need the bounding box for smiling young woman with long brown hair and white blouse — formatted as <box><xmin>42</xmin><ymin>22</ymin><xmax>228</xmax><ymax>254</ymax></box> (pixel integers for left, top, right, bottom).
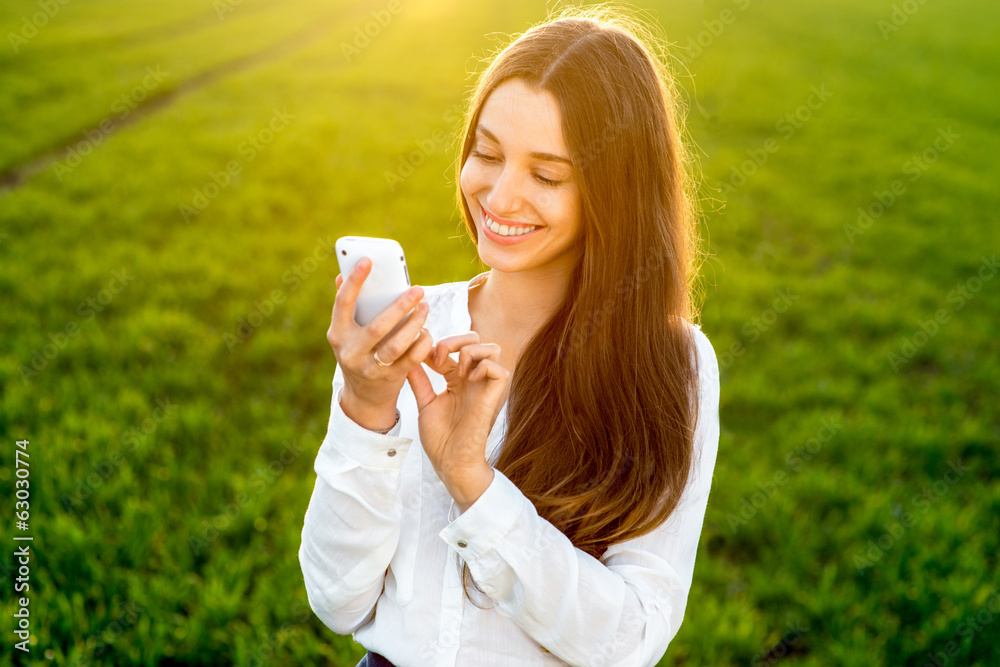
<box><xmin>299</xmin><ymin>9</ymin><xmax>719</xmax><ymax>667</ymax></box>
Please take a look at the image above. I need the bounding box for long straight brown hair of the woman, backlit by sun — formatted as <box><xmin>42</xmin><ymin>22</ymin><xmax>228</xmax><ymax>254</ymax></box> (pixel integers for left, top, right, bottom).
<box><xmin>457</xmin><ymin>4</ymin><xmax>703</xmax><ymax>601</ymax></box>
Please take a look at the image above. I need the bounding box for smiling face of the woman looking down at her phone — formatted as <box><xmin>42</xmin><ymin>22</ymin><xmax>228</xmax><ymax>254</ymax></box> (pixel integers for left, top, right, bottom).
<box><xmin>461</xmin><ymin>79</ymin><xmax>580</xmax><ymax>272</ymax></box>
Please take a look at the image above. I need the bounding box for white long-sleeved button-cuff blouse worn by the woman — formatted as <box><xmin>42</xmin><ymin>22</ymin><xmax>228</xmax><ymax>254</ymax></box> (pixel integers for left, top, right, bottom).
<box><xmin>299</xmin><ymin>274</ymin><xmax>719</xmax><ymax>667</ymax></box>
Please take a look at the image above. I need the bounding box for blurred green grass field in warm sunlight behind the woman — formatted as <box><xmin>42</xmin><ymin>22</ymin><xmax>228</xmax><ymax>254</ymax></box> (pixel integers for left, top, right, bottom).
<box><xmin>0</xmin><ymin>0</ymin><xmax>1000</xmax><ymax>667</ymax></box>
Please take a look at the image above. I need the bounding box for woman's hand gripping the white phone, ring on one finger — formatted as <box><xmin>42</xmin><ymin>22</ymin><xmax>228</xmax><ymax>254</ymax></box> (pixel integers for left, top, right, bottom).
<box><xmin>326</xmin><ymin>258</ymin><xmax>434</xmax><ymax>430</ymax></box>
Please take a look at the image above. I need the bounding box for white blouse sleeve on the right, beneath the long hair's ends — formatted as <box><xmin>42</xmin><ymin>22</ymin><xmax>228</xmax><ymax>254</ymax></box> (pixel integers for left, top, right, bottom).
<box><xmin>439</xmin><ymin>325</ymin><xmax>720</xmax><ymax>667</ymax></box>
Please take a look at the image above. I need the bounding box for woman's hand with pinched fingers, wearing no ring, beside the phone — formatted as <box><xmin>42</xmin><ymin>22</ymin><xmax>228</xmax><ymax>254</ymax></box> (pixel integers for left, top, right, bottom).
<box><xmin>406</xmin><ymin>331</ymin><xmax>510</xmax><ymax>504</ymax></box>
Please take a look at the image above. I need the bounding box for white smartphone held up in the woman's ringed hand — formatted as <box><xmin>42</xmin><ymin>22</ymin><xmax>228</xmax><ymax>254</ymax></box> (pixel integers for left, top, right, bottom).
<box><xmin>334</xmin><ymin>236</ymin><xmax>413</xmax><ymax>337</ymax></box>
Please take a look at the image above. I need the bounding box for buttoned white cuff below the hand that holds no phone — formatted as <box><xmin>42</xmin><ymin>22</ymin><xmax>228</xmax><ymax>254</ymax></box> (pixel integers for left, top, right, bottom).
<box><xmin>438</xmin><ymin>468</ymin><xmax>533</xmax><ymax>562</ymax></box>
